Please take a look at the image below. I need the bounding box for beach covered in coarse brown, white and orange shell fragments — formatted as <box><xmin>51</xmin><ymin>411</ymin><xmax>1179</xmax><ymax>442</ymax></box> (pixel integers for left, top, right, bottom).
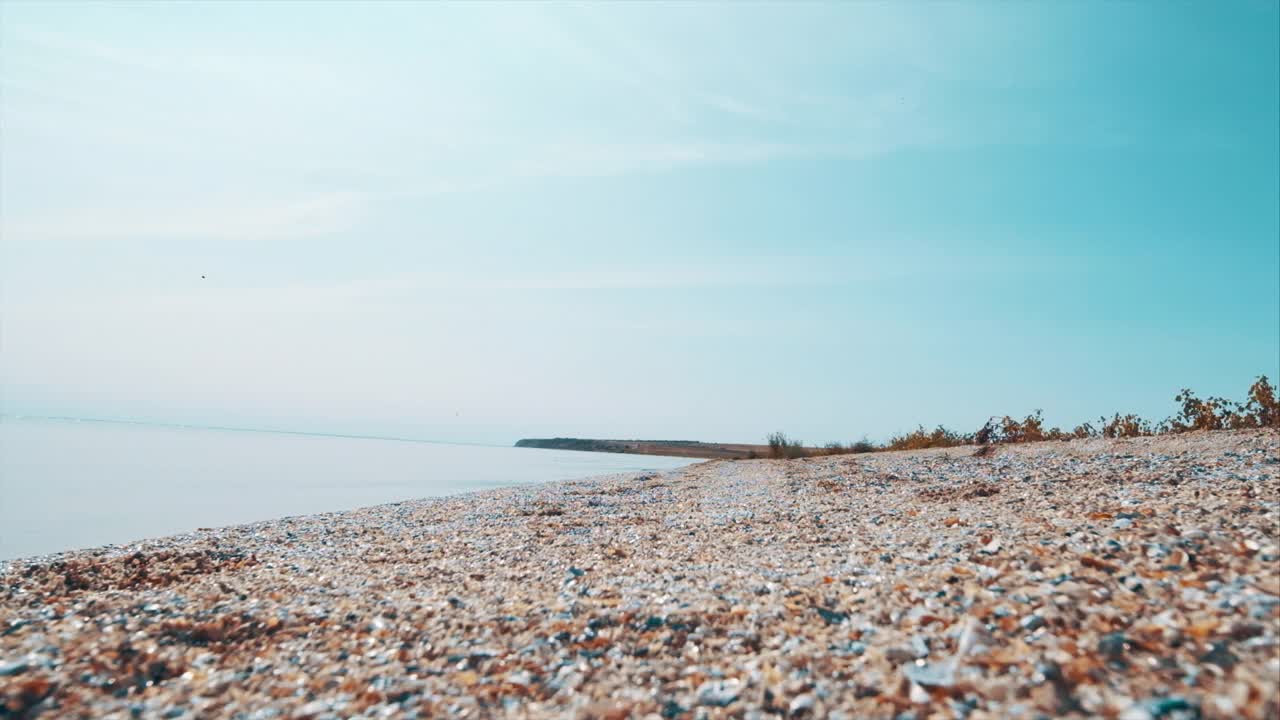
<box><xmin>0</xmin><ymin>430</ymin><xmax>1280</xmax><ymax>720</ymax></box>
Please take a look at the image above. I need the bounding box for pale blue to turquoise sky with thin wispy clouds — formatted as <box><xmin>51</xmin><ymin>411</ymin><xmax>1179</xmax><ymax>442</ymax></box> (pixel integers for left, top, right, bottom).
<box><xmin>0</xmin><ymin>0</ymin><xmax>1280</xmax><ymax>443</ymax></box>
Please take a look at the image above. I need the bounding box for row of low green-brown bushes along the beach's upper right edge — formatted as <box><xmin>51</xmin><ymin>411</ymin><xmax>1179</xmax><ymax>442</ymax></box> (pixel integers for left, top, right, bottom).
<box><xmin>769</xmin><ymin>375</ymin><xmax>1280</xmax><ymax>457</ymax></box>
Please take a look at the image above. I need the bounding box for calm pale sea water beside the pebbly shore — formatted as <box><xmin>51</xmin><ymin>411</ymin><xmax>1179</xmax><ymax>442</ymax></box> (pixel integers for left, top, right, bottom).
<box><xmin>0</xmin><ymin>418</ymin><xmax>690</xmax><ymax>560</ymax></box>
